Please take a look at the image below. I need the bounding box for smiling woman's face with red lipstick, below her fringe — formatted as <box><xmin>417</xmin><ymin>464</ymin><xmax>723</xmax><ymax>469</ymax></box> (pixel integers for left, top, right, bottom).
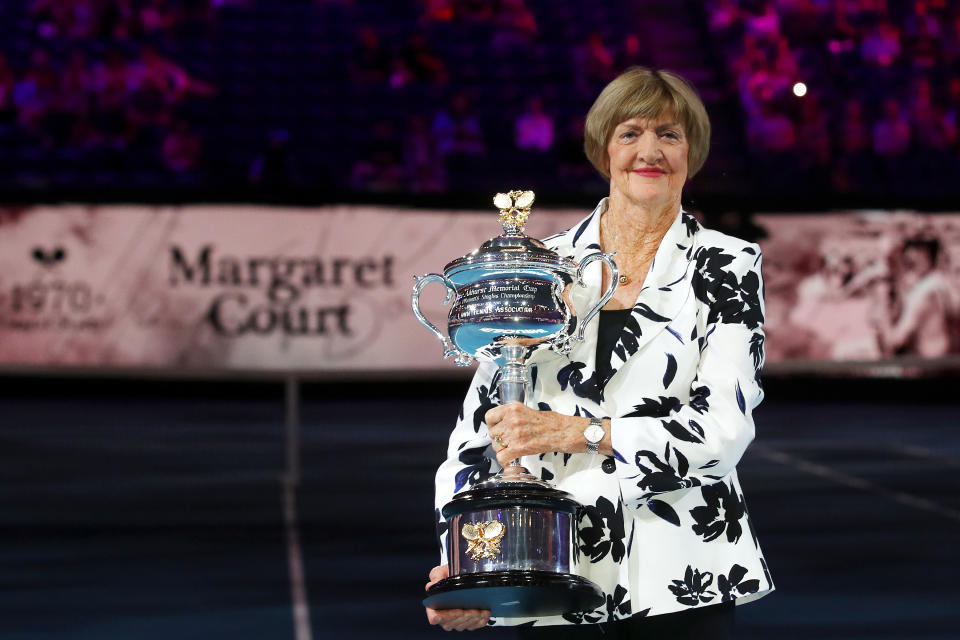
<box><xmin>607</xmin><ymin>113</ymin><xmax>690</xmax><ymax>208</ymax></box>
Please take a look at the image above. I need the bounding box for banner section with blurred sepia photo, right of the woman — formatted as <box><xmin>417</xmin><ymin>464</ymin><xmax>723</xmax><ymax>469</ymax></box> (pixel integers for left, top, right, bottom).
<box><xmin>755</xmin><ymin>211</ymin><xmax>960</xmax><ymax>366</ymax></box>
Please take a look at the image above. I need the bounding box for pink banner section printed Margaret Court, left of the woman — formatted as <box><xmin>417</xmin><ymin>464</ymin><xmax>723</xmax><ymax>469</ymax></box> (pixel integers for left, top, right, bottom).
<box><xmin>0</xmin><ymin>206</ymin><xmax>589</xmax><ymax>372</ymax></box>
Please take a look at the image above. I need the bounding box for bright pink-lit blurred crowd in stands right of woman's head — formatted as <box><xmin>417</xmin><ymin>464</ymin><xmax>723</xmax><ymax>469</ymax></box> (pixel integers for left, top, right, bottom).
<box><xmin>707</xmin><ymin>0</ymin><xmax>960</xmax><ymax>194</ymax></box>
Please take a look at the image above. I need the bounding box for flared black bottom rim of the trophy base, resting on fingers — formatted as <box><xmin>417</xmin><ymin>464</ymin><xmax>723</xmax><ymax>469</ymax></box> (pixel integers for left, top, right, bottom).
<box><xmin>423</xmin><ymin>570</ymin><xmax>604</xmax><ymax>617</ymax></box>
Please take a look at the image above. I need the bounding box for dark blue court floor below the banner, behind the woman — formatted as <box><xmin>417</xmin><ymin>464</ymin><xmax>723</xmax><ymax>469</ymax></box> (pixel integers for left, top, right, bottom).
<box><xmin>0</xmin><ymin>378</ymin><xmax>960</xmax><ymax>640</ymax></box>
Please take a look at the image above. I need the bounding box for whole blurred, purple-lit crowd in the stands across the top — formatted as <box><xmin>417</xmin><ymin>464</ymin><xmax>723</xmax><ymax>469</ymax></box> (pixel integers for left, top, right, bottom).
<box><xmin>0</xmin><ymin>0</ymin><xmax>960</xmax><ymax>196</ymax></box>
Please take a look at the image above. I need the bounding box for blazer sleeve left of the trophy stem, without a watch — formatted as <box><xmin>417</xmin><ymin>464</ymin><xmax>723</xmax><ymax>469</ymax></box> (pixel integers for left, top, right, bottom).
<box><xmin>434</xmin><ymin>363</ymin><xmax>501</xmax><ymax>564</ymax></box>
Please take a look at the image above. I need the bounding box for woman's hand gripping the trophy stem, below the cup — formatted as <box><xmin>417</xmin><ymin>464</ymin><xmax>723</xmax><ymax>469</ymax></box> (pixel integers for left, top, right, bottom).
<box><xmin>484</xmin><ymin>402</ymin><xmax>590</xmax><ymax>467</ymax></box>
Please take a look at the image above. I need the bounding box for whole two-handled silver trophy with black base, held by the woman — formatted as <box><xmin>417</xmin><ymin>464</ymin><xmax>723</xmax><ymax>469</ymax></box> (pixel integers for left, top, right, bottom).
<box><xmin>411</xmin><ymin>191</ymin><xmax>619</xmax><ymax>616</ymax></box>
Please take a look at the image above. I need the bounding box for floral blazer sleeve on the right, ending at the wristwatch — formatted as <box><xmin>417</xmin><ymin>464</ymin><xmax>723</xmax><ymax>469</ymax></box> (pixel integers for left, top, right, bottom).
<box><xmin>611</xmin><ymin>244</ymin><xmax>764</xmax><ymax>508</ymax></box>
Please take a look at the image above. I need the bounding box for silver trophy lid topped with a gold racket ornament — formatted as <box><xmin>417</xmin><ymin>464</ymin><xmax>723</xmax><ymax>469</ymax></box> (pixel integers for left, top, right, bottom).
<box><xmin>444</xmin><ymin>190</ymin><xmax>577</xmax><ymax>275</ymax></box>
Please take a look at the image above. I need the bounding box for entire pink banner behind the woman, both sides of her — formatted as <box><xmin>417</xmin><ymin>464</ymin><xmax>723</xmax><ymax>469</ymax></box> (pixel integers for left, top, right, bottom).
<box><xmin>0</xmin><ymin>205</ymin><xmax>960</xmax><ymax>374</ymax></box>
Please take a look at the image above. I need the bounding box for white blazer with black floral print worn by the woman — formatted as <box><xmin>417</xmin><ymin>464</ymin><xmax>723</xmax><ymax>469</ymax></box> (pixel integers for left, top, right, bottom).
<box><xmin>436</xmin><ymin>199</ymin><xmax>773</xmax><ymax>626</ymax></box>
